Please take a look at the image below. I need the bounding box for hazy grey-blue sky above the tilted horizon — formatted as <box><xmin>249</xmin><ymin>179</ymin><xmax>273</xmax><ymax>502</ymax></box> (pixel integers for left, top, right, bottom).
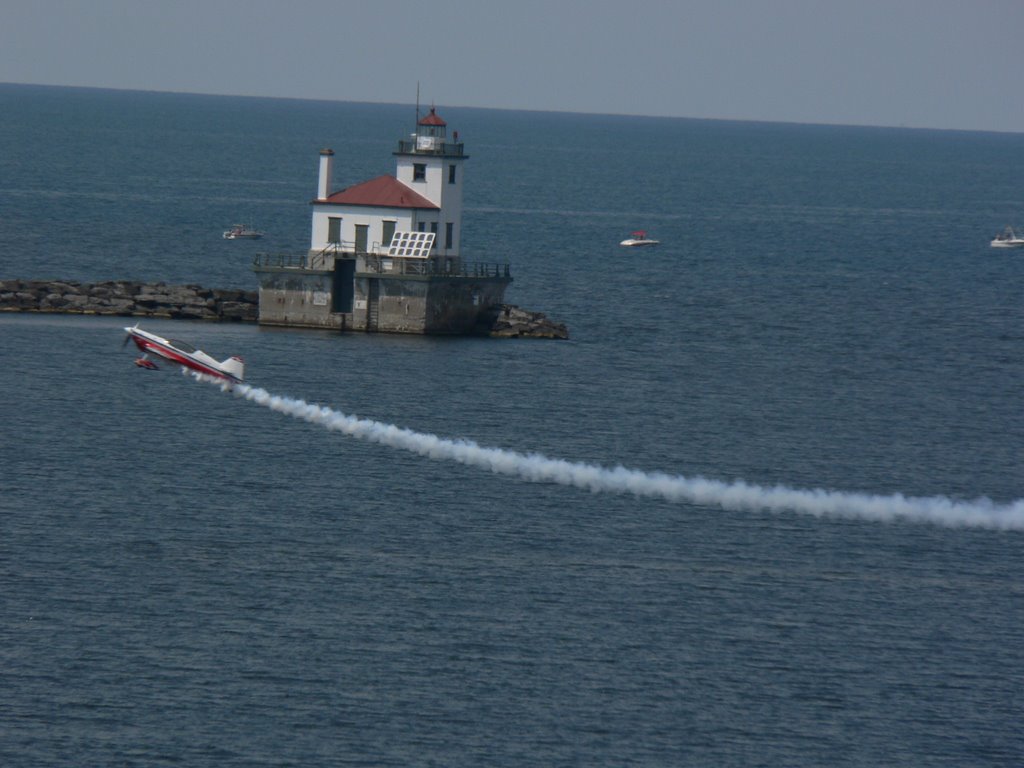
<box><xmin>0</xmin><ymin>0</ymin><xmax>1024</xmax><ymax>132</ymax></box>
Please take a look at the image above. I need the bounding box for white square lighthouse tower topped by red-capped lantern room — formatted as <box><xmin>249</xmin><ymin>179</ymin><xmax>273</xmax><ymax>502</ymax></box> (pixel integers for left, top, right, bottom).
<box><xmin>394</xmin><ymin>106</ymin><xmax>469</xmax><ymax>257</ymax></box>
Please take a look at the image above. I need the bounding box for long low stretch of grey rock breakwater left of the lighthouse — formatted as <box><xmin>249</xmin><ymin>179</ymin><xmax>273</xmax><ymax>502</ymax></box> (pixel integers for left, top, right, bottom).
<box><xmin>0</xmin><ymin>280</ymin><xmax>259</xmax><ymax>323</ymax></box>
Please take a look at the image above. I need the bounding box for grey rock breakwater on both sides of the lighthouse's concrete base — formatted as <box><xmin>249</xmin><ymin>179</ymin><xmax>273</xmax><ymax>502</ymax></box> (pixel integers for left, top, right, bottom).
<box><xmin>0</xmin><ymin>280</ymin><xmax>568</xmax><ymax>339</ymax></box>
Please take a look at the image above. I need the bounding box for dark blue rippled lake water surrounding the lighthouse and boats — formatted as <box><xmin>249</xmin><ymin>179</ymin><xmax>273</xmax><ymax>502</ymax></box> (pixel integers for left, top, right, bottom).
<box><xmin>0</xmin><ymin>86</ymin><xmax>1024</xmax><ymax>768</ymax></box>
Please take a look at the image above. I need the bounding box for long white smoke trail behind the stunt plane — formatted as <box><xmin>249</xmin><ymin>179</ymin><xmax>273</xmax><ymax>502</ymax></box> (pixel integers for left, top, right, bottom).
<box><xmin>205</xmin><ymin>376</ymin><xmax>1024</xmax><ymax>530</ymax></box>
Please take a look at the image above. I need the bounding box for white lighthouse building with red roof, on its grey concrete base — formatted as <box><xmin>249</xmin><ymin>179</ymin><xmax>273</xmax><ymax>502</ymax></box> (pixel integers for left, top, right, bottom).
<box><xmin>255</xmin><ymin>108</ymin><xmax>512</xmax><ymax>334</ymax></box>
